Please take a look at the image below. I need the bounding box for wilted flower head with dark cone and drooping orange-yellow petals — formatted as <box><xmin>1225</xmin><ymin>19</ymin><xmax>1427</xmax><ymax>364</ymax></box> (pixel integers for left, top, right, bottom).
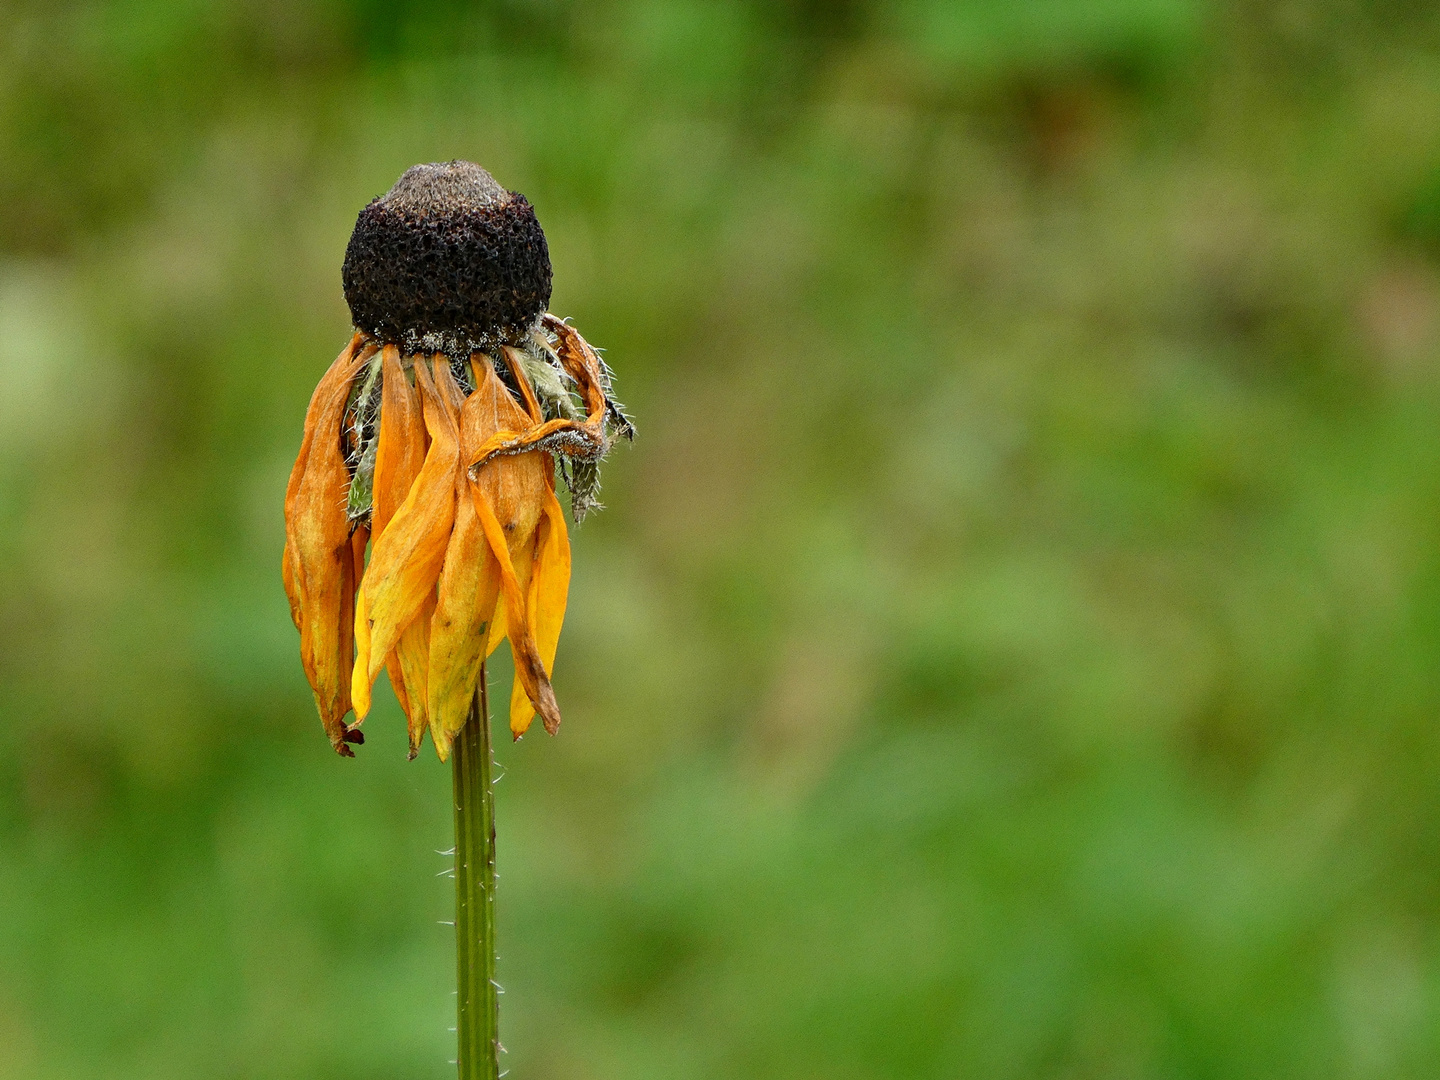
<box><xmin>284</xmin><ymin>161</ymin><xmax>634</xmax><ymax>760</ymax></box>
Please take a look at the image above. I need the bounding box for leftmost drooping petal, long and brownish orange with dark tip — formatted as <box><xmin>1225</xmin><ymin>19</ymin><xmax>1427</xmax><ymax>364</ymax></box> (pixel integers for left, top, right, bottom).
<box><xmin>282</xmin><ymin>340</ymin><xmax>373</xmax><ymax>756</ymax></box>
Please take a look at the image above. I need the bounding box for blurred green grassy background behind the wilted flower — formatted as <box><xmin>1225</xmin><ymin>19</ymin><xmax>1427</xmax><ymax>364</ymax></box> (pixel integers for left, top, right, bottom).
<box><xmin>0</xmin><ymin>0</ymin><xmax>1440</xmax><ymax>1080</ymax></box>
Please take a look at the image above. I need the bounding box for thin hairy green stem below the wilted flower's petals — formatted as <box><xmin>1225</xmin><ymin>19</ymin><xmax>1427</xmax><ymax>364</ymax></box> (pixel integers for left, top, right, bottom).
<box><xmin>452</xmin><ymin>665</ymin><xmax>500</xmax><ymax>1080</ymax></box>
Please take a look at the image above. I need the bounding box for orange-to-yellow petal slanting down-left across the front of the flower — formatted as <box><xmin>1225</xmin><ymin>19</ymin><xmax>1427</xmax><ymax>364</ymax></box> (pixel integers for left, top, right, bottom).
<box><xmin>353</xmin><ymin>359</ymin><xmax>459</xmax><ymax>714</ymax></box>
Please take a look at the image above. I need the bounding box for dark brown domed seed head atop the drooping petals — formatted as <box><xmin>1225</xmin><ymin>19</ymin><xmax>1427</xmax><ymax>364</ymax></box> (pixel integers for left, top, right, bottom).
<box><xmin>340</xmin><ymin>161</ymin><xmax>550</xmax><ymax>359</ymax></box>
